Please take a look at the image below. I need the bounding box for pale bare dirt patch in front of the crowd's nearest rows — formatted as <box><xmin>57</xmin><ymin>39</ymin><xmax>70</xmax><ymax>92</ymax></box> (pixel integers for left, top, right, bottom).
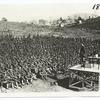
<box><xmin>1</xmin><ymin>79</ymin><xmax>72</xmax><ymax>93</ymax></box>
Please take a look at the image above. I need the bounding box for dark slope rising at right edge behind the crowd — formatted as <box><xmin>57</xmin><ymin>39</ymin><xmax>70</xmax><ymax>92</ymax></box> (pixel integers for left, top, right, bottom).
<box><xmin>71</xmin><ymin>16</ymin><xmax>100</xmax><ymax>37</ymax></box>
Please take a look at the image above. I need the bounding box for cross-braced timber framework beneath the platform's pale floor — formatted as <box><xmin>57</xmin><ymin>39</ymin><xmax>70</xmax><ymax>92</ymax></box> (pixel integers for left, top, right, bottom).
<box><xmin>69</xmin><ymin>66</ymin><xmax>100</xmax><ymax>91</ymax></box>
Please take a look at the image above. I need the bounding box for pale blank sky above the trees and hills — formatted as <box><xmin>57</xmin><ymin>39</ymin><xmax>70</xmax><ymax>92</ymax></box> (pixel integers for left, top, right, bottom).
<box><xmin>0</xmin><ymin>0</ymin><xmax>100</xmax><ymax>21</ymax></box>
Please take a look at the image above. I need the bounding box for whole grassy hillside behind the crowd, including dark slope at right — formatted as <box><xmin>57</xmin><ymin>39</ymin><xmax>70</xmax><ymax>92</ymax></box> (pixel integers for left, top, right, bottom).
<box><xmin>0</xmin><ymin>17</ymin><xmax>100</xmax><ymax>38</ymax></box>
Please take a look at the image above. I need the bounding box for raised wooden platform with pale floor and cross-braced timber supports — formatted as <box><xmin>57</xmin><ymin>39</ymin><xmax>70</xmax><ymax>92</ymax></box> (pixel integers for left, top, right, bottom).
<box><xmin>69</xmin><ymin>63</ymin><xmax>100</xmax><ymax>91</ymax></box>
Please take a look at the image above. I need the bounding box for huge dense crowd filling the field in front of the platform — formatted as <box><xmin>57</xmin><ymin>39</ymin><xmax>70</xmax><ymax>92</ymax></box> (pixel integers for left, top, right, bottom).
<box><xmin>0</xmin><ymin>35</ymin><xmax>100</xmax><ymax>88</ymax></box>
